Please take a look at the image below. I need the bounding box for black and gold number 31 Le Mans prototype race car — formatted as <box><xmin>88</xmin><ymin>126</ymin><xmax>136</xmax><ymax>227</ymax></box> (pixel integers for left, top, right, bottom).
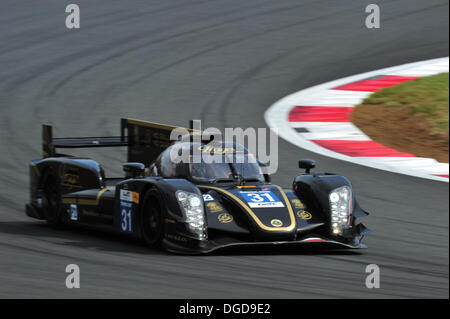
<box><xmin>26</xmin><ymin>119</ymin><xmax>369</xmax><ymax>254</ymax></box>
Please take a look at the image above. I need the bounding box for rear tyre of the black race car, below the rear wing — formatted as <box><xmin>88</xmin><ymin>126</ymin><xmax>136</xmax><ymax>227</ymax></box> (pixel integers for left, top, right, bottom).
<box><xmin>43</xmin><ymin>174</ymin><xmax>62</xmax><ymax>227</ymax></box>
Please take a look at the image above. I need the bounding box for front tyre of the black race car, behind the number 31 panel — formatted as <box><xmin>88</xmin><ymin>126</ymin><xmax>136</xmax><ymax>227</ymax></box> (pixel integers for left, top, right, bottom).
<box><xmin>141</xmin><ymin>190</ymin><xmax>164</xmax><ymax>248</ymax></box>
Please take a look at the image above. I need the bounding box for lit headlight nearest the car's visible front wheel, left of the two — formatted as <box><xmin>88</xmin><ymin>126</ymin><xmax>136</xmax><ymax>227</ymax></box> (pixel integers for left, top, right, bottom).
<box><xmin>175</xmin><ymin>191</ymin><xmax>206</xmax><ymax>240</ymax></box>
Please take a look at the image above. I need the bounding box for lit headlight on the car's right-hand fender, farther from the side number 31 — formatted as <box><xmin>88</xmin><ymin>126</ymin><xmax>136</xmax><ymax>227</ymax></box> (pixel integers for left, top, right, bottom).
<box><xmin>328</xmin><ymin>186</ymin><xmax>352</xmax><ymax>235</ymax></box>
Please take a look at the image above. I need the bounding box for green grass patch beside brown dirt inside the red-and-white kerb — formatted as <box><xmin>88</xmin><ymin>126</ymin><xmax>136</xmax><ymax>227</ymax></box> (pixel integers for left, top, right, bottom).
<box><xmin>363</xmin><ymin>73</ymin><xmax>449</xmax><ymax>140</ymax></box>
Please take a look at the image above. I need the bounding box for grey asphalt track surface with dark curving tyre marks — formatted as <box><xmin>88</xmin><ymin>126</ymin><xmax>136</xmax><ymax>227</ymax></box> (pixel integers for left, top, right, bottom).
<box><xmin>0</xmin><ymin>0</ymin><xmax>449</xmax><ymax>298</ymax></box>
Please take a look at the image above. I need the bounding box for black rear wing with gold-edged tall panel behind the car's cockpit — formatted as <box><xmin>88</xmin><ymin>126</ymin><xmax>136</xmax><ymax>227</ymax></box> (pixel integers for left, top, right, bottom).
<box><xmin>42</xmin><ymin>118</ymin><xmax>193</xmax><ymax>166</ymax></box>
